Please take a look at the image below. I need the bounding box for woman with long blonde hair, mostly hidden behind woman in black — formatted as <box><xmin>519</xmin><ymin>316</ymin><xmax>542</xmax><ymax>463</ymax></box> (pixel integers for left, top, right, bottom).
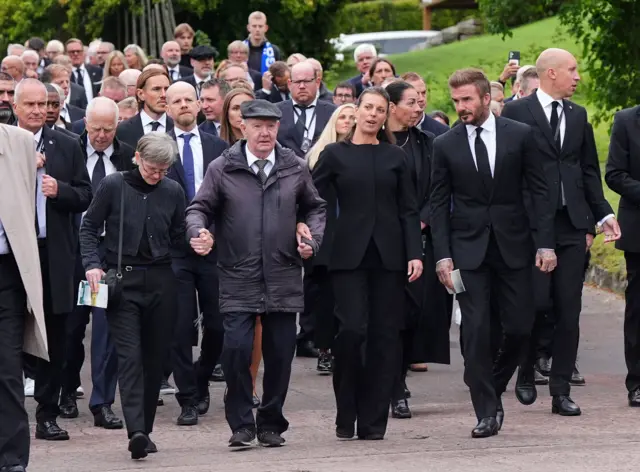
<box><xmin>304</xmin><ymin>103</ymin><xmax>356</xmax><ymax>375</ymax></box>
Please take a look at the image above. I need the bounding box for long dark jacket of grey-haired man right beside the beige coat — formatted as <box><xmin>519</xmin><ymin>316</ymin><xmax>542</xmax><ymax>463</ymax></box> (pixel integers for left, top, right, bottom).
<box><xmin>42</xmin><ymin>126</ymin><xmax>91</xmax><ymax>313</ymax></box>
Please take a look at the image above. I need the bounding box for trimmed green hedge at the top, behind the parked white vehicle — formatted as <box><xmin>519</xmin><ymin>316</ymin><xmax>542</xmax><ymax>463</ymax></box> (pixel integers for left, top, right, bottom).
<box><xmin>335</xmin><ymin>0</ymin><xmax>474</xmax><ymax>34</ymax></box>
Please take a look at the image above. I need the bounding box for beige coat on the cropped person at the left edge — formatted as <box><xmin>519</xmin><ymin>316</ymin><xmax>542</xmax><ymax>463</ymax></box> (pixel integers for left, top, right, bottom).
<box><xmin>0</xmin><ymin>124</ymin><xmax>49</xmax><ymax>360</ymax></box>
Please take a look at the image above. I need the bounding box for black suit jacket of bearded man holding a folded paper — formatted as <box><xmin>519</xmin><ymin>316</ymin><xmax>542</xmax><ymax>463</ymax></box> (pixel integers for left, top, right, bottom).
<box><xmin>430</xmin><ymin>117</ymin><xmax>555</xmax><ymax>270</ymax></box>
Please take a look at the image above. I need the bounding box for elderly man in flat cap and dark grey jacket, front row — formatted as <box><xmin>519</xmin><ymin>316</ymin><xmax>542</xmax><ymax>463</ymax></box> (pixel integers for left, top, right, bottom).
<box><xmin>187</xmin><ymin>100</ymin><xmax>325</xmax><ymax>447</ymax></box>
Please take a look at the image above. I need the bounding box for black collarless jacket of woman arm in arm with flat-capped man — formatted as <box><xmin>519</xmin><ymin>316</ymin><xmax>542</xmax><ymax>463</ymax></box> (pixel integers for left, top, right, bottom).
<box><xmin>313</xmin><ymin>142</ymin><xmax>422</xmax><ymax>271</ymax></box>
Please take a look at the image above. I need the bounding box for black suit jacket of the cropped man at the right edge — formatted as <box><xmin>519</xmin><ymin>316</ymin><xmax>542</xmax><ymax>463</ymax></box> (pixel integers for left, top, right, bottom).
<box><xmin>604</xmin><ymin>106</ymin><xmax>640</xmax><ymax>252</ymax></box>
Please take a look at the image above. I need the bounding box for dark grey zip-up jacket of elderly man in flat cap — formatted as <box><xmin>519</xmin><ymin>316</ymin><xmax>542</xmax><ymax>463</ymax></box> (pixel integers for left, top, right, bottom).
<box><xmin>187</xmin><ymin>140</ymin><xmax>325</xmax><ymax>313</ymax></box>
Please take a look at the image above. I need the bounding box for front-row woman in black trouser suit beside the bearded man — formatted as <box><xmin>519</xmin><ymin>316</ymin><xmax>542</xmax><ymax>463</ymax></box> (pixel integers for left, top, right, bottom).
<box><xmin>313</xmin><ymin>87</ymin><xmax>422</xmax><ymax>439</ymax></box>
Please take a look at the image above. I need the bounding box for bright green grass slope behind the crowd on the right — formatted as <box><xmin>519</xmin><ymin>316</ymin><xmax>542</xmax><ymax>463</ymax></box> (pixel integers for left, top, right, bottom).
<box><xmin>327</xmin><ymin>18</ymin><xmax>624</xmax><ymax>278</ymax></box>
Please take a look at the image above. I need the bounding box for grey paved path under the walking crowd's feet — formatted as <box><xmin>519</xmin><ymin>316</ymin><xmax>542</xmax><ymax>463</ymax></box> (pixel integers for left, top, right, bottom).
<box><xmin>26</xmin><ymin>289</ymin><xmax>640</xmax><ymax>472</ymax></box>
